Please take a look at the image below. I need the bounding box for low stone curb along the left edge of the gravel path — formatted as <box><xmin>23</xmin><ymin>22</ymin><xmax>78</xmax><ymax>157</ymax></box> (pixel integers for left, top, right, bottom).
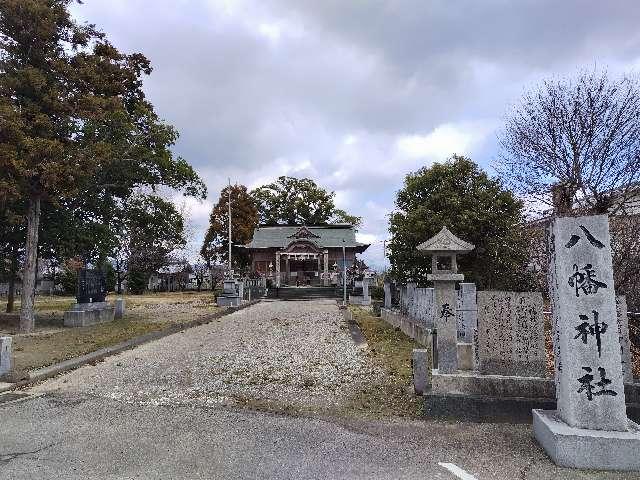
<box><xmin>0</xmin><ymin>299</ymin><xmax>261</xmax><ymax>393</ymax></box>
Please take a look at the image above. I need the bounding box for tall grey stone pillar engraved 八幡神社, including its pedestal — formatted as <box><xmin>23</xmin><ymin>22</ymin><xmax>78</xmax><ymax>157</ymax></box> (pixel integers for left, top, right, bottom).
<box><xmin>533</xmin><ymin>215</ymin><xmax>640</xmax><ymax>470</ymax></box>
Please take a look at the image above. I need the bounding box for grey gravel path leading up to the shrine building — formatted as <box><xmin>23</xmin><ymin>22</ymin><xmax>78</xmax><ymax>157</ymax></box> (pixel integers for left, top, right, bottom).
<box><xmin>35</xmin><ymin>300</ymin><xmax>383</xmax><ymax>411</ymax></box>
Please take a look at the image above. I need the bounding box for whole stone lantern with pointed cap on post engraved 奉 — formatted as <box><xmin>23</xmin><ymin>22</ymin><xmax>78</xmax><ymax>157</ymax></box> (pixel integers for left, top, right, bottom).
<box><xmin>418</xmin><ymin>227</ymin><xmax>475</xmax><ymax>373</ymax></box>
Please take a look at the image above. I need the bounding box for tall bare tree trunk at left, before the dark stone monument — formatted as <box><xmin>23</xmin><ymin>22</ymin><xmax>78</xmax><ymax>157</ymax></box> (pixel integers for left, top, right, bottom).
<box><xmin>18</xmin><ymin>197</ymin><xmax>40</xmax><ymax>333</ymax></box>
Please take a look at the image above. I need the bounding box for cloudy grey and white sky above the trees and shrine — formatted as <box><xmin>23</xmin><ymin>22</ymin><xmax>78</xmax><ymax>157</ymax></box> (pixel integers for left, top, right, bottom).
<box><xmin>73</xmin><ymin>0</ymin><xmax>640</xmax><ymax>267</ymax></box>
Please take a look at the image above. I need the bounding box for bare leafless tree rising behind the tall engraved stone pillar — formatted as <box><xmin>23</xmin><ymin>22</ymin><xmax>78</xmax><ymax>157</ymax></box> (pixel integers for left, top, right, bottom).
<box><xmin>498</xmin><ymin>73</ymin><xmax>640</xmax><ymax>214</ymax></box>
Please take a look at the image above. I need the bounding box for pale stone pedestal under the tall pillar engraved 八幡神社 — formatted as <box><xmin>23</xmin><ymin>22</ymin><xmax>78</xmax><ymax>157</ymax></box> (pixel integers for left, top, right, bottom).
<box><xmin>532</xmin><ymin>410</ymin><xmax>640</xmax><ymax>471</ymax></box>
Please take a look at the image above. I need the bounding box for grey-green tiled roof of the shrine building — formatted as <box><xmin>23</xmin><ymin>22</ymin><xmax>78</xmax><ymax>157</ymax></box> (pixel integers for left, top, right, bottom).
<box><xmin>245</xmin><ymin>224</ymin><xmax>369</xmax><ymax>251</ymax></box>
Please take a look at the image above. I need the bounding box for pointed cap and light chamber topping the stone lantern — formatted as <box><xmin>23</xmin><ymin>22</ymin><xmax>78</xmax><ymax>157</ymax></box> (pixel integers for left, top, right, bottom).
<box><xmin>417</xmin><ymin>227</ymin><xmax>476</xmax><ymax>281</ymax></box>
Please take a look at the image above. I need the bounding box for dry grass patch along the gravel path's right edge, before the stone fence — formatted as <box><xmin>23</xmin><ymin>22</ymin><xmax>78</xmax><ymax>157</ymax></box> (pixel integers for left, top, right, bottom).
<box><xmin>348</xmin><ymin>307</ymin><xmax>425</xmax><ymax>418</ymax></box>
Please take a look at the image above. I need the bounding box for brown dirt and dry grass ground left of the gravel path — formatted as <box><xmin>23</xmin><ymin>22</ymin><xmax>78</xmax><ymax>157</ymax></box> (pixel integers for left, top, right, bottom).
<box><xmin>0</xmin><ymin>292</ymin><xmax>219</xmax><ymax>370</ymax></box>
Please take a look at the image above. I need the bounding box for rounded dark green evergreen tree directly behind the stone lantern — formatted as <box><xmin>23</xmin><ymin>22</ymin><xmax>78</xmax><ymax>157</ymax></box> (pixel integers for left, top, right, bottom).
<box><xmin>389</xmin><ymin>155</ymin><xmax>532</xmax><ymax>290</ymax></box>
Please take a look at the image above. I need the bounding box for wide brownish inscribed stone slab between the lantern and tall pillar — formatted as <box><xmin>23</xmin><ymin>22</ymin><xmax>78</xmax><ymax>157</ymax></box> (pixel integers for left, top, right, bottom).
<box><xmin>476</xmin><ymin>291</ymin><xmax>546</xmax><ymax>377</ymax></box>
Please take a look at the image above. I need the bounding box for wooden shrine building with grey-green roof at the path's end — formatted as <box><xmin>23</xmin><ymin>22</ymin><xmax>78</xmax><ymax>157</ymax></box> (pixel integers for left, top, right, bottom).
<box><xmin>245</xmin><ymin>224</ymin><xmax>369</xmax><ymax>287</ymax></box>
